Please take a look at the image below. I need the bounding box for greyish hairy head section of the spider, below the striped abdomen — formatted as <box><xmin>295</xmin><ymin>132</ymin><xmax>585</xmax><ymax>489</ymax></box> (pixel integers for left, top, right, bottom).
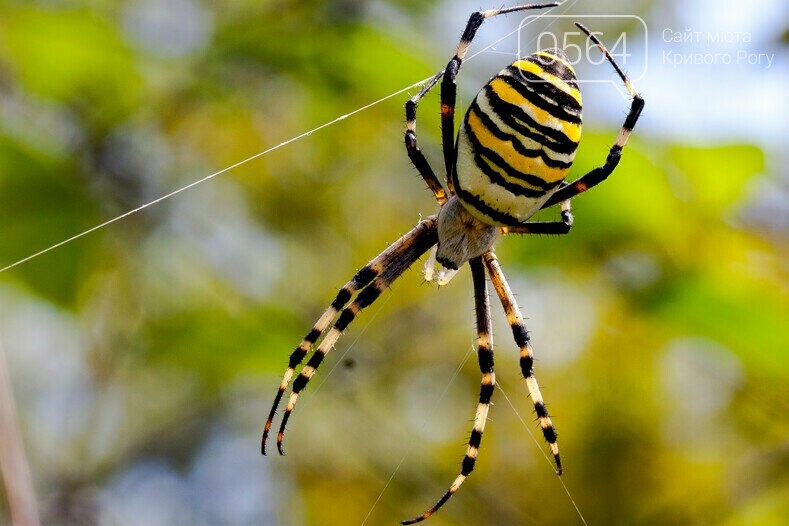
<box><xmin>436</xmin><ymin>196</ymin><xmax>500</xmax><ymax>278</ymax></box>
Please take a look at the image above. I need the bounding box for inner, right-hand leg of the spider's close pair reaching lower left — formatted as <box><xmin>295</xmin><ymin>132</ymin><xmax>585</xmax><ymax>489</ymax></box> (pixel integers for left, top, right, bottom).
<box><xmin>277</xmin><ymin>216</ymin><xmax>438</xmax><ymax>455</ymax></box>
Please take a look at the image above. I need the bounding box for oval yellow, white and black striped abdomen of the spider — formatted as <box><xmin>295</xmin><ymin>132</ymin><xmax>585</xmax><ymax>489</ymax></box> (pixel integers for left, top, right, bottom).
<box><xmin>453</xmin><ymin>49</ymin><xmax>581</xmax><ymax>225</ymax></box>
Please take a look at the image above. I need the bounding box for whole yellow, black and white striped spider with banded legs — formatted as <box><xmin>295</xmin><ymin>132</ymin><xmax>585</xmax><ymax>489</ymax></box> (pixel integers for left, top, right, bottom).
<box><xmin>261</xmin><ymin>3</ymin><xmax>644</xmax><ymax>524</ymax></box>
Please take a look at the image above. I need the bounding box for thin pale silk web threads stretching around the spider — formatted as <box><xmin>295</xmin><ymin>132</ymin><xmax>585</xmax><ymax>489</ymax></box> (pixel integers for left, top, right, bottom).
<box><xmin>0</xmin><ymin>0</ymin><xmax>587</xmax><ymax>526</ymax></box>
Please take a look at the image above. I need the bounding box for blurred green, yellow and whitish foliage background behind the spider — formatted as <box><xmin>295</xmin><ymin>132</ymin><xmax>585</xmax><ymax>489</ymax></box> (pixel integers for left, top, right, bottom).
<box><xmin>0</xmin><ymin>0</ymin><xmax>789</xmax><ymax>526</ymax></box>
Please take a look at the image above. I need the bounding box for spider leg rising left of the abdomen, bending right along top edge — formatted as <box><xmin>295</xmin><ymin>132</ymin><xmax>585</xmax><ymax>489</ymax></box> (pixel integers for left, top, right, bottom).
<box><xmin>441</xmin><ymin>2</ymin><xmax>559</xmax><ymax>185</ymax></box>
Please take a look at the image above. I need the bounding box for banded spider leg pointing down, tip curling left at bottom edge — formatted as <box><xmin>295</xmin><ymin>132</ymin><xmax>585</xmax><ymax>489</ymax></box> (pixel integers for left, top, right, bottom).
<box><xmin>401</xmin><ymin>257</ymin><xmax>496</xmax><ymax>524</ymax></box>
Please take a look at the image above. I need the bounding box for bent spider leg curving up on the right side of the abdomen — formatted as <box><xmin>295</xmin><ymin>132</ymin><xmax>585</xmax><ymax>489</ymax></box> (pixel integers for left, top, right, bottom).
<box><xmin>542</xmin><ymin>23</ymin><xmax>644</xmax><ymax>208</ymax></box>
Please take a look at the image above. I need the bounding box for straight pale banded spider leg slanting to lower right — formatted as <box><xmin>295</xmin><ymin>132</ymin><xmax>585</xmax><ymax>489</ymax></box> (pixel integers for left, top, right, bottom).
<box><xmin>482</xmin><ymin>251</ymin><xmax>562</xmax><ymax>475</ymax></box>
